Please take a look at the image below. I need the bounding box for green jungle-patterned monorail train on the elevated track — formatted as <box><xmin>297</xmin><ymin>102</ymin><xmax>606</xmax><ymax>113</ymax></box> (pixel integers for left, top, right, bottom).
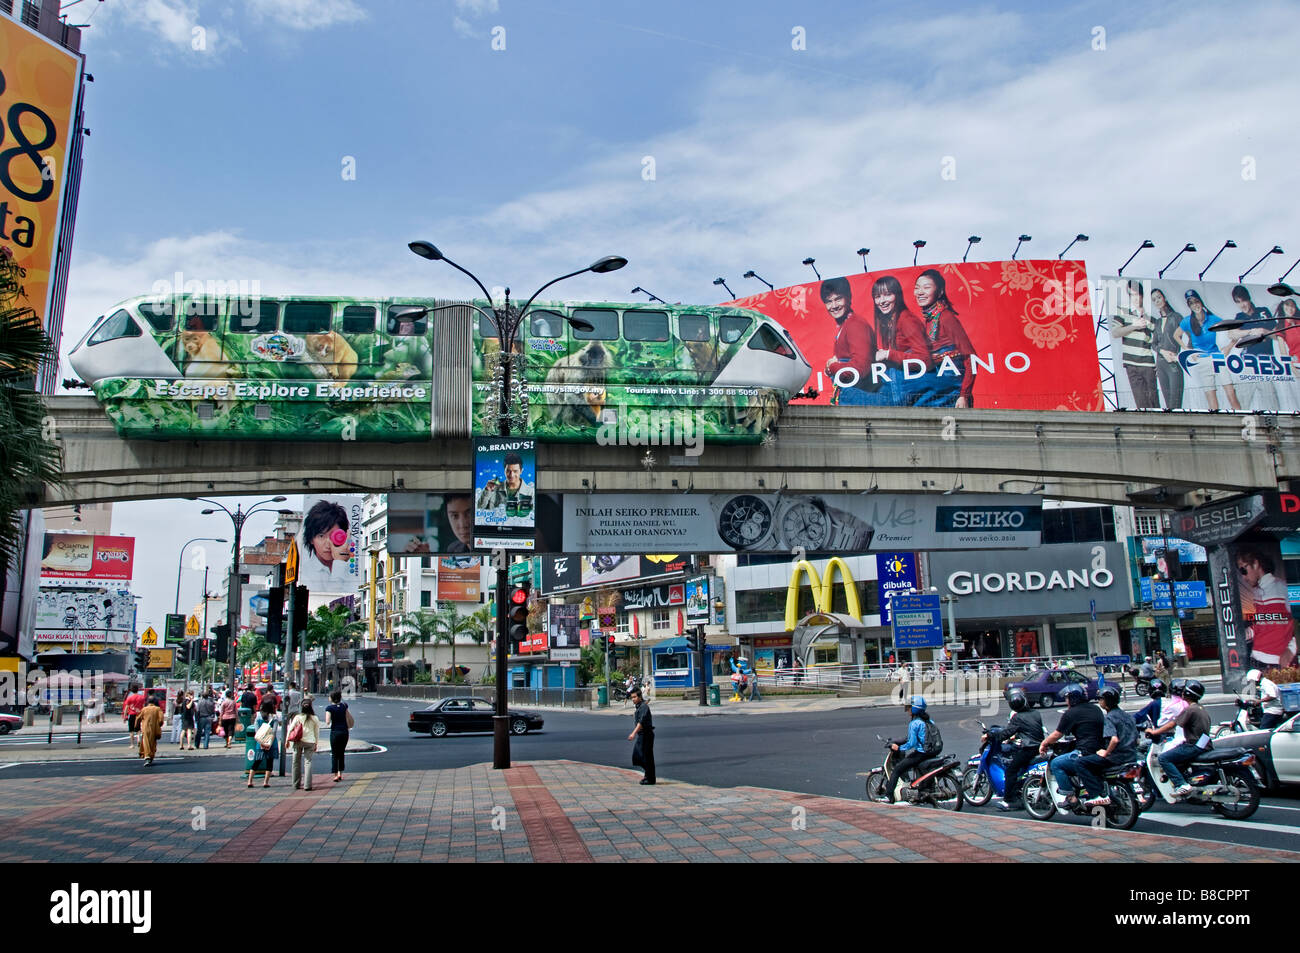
<box><xmin>68</xmin><ymin>295</ymin><xmax>811</xmax><ymax>443</ymax></box>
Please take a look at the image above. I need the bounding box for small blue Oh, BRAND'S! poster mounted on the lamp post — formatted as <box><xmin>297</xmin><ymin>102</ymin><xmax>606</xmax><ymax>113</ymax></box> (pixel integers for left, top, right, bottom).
<box><xmin>475</xmin><ymin>437</ymin><xmax>537</xmax><ymax>550</ymax></box>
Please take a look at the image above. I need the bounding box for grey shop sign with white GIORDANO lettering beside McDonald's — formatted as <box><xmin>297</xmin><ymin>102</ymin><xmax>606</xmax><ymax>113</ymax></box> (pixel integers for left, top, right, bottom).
<box><xmin>930</xmin><ymin>542</ymin><xmax>1132</xmax><ymax>618</ymax></box>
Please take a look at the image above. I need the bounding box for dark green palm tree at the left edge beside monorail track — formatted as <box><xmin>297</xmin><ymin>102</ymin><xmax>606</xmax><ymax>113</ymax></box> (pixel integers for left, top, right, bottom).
<box><xmin>0</xmin><ymin>248</ymin><xmax>62</xmax><ymax>599</ymax></box>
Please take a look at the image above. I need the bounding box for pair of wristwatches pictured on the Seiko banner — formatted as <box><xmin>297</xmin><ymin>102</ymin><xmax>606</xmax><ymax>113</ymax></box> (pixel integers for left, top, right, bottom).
<box><xmin>718</xmin><ymin>494</ymin><xmax>875</xmax><ymax>553</ymax></box>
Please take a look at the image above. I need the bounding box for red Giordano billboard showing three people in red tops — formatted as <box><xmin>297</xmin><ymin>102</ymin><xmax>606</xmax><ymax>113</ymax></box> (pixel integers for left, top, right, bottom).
<box><xmin>733</xmin><ymin>261</ymin><xmax>1104</xmax><ymax>411</ymax></box>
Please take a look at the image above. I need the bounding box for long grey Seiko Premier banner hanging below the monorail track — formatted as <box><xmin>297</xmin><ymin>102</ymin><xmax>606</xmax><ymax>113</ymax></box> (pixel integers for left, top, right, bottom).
<box><xmin>562</xmin><ymin>493</ymin><xmax>1043</xmax><ymax>555</ymax></box>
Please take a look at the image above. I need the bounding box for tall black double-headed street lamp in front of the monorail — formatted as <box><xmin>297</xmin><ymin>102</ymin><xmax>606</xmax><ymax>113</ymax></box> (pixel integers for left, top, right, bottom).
<box><xmin>407</xmin><ymin>242</ymin><xmax>628</xmax><ymax>768</ymax></box>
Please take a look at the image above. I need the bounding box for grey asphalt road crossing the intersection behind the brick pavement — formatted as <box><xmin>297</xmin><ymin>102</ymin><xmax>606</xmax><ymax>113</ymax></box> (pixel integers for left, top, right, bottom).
<box><xmin>0</xmin><ymin>697</ymin><xmax>1300</xmax><ymax>852</ymax></box>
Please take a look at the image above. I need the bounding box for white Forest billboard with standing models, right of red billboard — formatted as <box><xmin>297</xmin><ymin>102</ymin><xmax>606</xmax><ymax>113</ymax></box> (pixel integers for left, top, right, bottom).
<box><xmin>1102</xmin><ymin>278</ymin><xmax>1300</xmax><ymax>413</ymax></box>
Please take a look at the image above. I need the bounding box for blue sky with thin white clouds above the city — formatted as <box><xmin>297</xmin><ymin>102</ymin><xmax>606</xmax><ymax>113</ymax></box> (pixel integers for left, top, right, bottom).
<box><xmin>65</xmin><ymin>0</ymin><xmax>1300</xmax><ymax>631</ymax></box>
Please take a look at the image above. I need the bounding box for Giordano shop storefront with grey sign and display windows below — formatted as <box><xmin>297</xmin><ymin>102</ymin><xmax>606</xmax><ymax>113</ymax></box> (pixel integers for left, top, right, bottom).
<box><xmin>930</xmin><ymin>542</ymin><xmax>1132</xmax><ymax>659</ymax></box>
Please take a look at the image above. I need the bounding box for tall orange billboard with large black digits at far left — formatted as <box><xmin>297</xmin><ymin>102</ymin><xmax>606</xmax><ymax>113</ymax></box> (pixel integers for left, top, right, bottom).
<box><xmin>0</xmin><ymin>17</ymin><xmax>82</xmax><ymax>371</ymax></box>
